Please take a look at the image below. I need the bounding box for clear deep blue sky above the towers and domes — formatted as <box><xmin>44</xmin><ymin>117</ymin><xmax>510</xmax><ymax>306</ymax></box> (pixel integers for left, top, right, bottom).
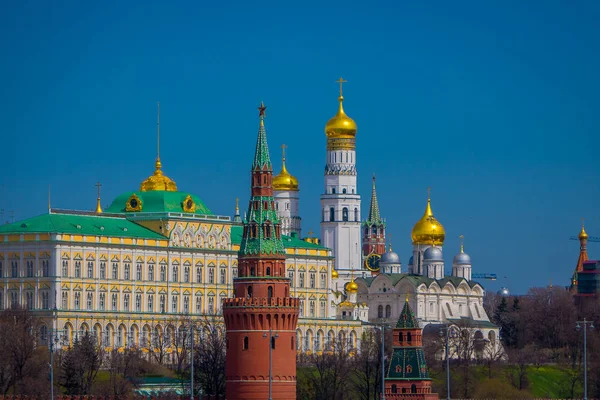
<box><xmin>0</xmin><ymin>1</ymin><xmax>600</xmax><ymax>293</ymax></box>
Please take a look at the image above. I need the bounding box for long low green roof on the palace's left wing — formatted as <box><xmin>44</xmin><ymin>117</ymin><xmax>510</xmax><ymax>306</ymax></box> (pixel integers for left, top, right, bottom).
<box><xmin>0</xmin><ymin>213</ymin><xmax>166</xmax><ymax>239</ymax></box>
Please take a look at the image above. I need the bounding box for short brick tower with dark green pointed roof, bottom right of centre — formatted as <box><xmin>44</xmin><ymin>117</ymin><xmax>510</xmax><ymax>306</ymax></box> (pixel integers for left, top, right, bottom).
<box><xmin>385</xmin><ymin>296</ymin><xmax>438</xmax><ymax>400</ymax></box>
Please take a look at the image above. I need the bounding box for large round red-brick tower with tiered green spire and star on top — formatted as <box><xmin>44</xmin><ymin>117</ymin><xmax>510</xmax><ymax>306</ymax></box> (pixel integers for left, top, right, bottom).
<box><xmin>223</xmin><ymin>104</ymin><xmax>299</xmax><ymax>400</ymax></box>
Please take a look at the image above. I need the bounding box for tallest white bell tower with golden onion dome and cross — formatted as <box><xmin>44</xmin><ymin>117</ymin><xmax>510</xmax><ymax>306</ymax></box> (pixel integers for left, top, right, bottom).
<box><xmin>321</xmin><ymin>78</ymin><xmax>362</xmax><ymax>280</ymax></box>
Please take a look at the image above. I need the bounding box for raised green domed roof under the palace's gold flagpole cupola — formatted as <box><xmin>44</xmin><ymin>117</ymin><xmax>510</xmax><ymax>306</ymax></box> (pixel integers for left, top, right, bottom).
<box><xmin>104</xmin><ymin>190</ymin><xmax>214</xmax><ymax>215</ymax></box>
